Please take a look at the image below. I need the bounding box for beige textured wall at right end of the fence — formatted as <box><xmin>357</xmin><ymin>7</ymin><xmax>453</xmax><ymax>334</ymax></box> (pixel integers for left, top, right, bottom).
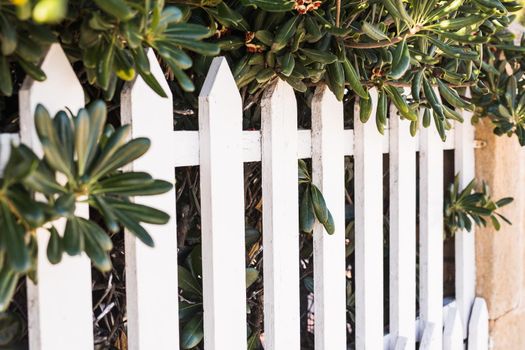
<box><xmin>476</xmin><ymin>120</ymin><xmax>525</xmax><ymax>350</ymax></box>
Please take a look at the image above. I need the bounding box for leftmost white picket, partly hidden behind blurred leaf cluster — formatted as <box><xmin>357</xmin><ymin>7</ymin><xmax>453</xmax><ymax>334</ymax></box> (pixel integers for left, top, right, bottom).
<box><xmin>19</xmin><ymin>44</ymin><xmax>93</xmax><ymax>350</ymax></box>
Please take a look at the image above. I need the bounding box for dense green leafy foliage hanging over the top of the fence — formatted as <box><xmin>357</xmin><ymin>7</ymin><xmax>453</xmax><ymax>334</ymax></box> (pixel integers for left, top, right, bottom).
<box><xmin>0</xmin><ymin>0</ymin><xmax>525</xmax><ymax>143</ymax></box>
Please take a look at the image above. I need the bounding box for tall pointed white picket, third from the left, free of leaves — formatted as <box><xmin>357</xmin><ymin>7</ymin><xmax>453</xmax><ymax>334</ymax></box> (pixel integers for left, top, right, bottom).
<box><xmin>199</xmin><ymin>57</ymin><xmax>247</xmax><ymax>350</ymax></box>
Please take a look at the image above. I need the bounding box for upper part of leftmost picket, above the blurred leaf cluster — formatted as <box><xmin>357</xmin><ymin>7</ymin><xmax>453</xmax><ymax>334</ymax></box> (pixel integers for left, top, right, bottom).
<box><xmin>19</xmin><ymin>43</ymin><xmax>84</xmax><ymax>155</ymax></box>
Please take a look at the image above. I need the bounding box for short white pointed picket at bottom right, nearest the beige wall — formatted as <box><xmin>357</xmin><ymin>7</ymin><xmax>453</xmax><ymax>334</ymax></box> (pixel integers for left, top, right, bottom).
<box><xmin>468</xmin><ymin>298</ymin><xmax>489</xmax><ymax>350</ymax></box>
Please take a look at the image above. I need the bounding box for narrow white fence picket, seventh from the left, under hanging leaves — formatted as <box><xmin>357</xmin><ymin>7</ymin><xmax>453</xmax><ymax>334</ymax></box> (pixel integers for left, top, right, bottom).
<box><xmin>389</xmin><ymin>100</ymin><xmax>416</xmax><ymax>350</ymax></box>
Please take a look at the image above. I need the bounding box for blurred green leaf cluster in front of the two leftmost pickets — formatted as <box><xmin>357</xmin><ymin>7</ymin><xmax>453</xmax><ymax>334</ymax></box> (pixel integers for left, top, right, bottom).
<box><xmin>0</xmin><ymin>101</ymin><xmax>172</xmax><ymax>311</ymax></box>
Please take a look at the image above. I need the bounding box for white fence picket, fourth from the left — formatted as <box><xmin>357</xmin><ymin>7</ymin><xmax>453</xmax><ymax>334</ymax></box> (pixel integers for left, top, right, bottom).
<box><xmin>261</xmin><ymin>80</ymin><xmax>300</xmax><ymax>350</ymax></box>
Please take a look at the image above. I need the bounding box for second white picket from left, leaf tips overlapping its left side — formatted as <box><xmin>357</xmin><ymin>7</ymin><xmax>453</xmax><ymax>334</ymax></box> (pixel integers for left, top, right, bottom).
<box><xmin>121</xmin><ymin>50</ymin><xmax>179</xmax><ymax>350</ymax></box>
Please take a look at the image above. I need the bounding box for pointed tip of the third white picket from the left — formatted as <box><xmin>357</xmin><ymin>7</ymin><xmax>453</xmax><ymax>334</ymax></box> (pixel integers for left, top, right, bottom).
<box><xmin>199</xmin><ymin>56</ymin><xmax>241</xmax><ymax>99</ymax></box>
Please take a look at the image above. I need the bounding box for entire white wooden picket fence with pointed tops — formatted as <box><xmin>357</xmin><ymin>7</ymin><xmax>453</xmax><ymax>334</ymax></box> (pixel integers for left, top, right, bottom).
<box><xmin>0</xmin><ymin>44</ymin><xmax>488</xmax><ymax>350</ymax></box>
